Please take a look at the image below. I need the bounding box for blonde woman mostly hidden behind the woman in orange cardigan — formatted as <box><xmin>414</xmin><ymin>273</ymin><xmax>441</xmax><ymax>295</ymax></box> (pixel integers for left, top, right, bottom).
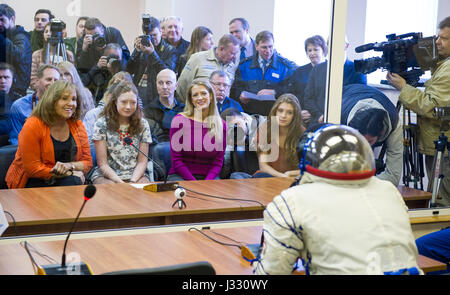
<box><xmin>58</xmin><ymin>61</ymin><xmax>95</xmax><ymax>120</ymax></box>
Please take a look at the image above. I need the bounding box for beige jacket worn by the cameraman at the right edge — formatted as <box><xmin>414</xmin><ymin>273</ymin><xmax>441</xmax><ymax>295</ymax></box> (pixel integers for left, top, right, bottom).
<box><xmin>399</xmin><ymin>58</ymin><xmax>450</xmax><ymax>155</ymax></box>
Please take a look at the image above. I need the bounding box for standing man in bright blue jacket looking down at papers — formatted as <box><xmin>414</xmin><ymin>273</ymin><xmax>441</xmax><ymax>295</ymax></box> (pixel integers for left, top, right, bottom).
<box><xmin>231</xmin><ymin>31</ymin><xmax>297</xmax><ymax>116</ymax></box>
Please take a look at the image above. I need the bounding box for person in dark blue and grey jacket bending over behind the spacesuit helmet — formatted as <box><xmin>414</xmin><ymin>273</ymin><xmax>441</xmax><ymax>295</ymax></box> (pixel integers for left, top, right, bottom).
<box><xmin>341</xmin><ymin>84</ymin><xmax>403</xmax><ymax>186</ymax></box>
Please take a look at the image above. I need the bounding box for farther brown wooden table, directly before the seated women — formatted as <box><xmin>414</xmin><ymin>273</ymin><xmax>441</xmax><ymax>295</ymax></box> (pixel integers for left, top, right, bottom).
<box><xmin>0</xmin><ymin>177</ymin><xmax>431</xmax><ymax>237</ymax></box>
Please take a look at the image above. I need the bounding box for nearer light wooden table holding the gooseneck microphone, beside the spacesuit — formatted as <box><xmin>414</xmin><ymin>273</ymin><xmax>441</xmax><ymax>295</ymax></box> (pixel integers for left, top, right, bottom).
<box><xmin>0</xmin><ymin>226</ymin><xmax>446</xmax><ymax>275</ymax></box>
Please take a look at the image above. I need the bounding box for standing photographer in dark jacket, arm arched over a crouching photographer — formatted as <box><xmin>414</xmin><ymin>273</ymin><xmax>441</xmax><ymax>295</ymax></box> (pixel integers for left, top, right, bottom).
<box><xmin>76</xmin><ymin>18</ymin><xmax>130</xmax><ymax>77</ymax></box>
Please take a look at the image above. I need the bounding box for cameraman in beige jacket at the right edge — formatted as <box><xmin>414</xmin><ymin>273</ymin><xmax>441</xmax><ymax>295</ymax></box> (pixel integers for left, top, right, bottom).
<box><xmin>386</xmin><ymin>17</ymin><xmax>450</xmax><ymax>206</ymax></box>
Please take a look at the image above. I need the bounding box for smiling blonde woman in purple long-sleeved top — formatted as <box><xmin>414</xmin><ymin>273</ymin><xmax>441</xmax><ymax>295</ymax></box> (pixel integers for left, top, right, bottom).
<box><xmin>168</xmin><ymin>82</ymin><xmax>226</xmax><ymax>180</ymax></box>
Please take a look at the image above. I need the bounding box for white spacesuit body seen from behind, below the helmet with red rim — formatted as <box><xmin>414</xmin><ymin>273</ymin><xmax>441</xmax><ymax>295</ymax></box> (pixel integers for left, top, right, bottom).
<box><xmin>254</xmin><ymin>173</ymin><xmax>423</xmax><ymax>275</ymax></box>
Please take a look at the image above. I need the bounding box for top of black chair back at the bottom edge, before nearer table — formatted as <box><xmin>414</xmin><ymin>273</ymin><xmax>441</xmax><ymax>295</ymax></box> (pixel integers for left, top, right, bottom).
<box><xmin>103</xmin><ymin>261</ymin><xmax>216</xmax><ymax>275</ymax></box>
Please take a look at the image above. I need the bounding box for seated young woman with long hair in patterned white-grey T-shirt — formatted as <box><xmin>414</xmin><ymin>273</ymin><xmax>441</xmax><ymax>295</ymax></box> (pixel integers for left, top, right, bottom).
<box><xmin>91</xmin><ymin>81</ymin><xmax>152</xmax><ymax>183</ymax></box>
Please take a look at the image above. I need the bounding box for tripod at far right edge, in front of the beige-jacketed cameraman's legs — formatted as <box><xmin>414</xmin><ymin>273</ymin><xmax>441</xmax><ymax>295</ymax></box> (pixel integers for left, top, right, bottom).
<box><xmin>428</xmin><ymin>121</ymin><xmax>450</xmax><ymax>208</ymax></box>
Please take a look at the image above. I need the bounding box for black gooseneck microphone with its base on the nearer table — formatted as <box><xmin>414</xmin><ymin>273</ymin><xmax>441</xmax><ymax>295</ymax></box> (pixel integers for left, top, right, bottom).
<box><xmin>37</xmin><ymin>184</ymin><xmax>97</xmax><ymax>275</ymax></box>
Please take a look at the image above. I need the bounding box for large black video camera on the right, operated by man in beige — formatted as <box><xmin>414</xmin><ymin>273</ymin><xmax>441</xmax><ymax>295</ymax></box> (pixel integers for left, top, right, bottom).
<box><xmin>355</xmin><ymin>33</ymin><xmax>438</xmax><ymax>87</ymax></box>
